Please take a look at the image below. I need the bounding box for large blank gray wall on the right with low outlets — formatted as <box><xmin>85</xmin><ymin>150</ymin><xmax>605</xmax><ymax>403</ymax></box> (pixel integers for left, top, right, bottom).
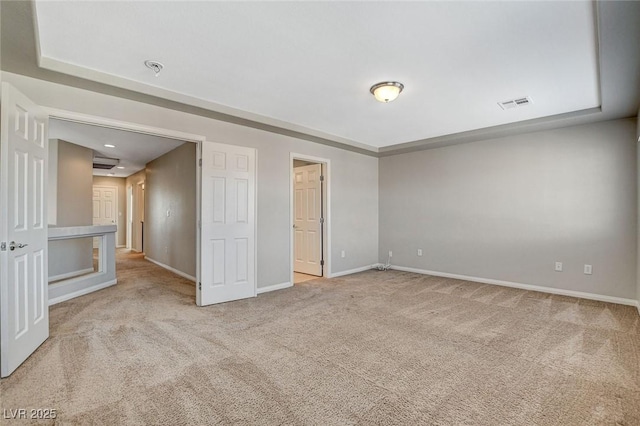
<box><xmin>379</xmin><ymin>119</ymin><xmax>638</xmax><ymax>299</ymax></box>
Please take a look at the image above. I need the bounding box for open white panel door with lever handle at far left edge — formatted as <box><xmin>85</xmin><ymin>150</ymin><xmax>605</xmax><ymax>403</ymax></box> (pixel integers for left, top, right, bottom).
<box><xmin>0</xmin><ymin>83</ymin><xmax>49</xmax><ymax>377</ymax></box>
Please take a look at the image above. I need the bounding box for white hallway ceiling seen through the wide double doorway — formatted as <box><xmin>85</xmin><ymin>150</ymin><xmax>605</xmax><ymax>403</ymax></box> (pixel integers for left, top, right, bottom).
<box><xmin>49</xmin><ymin>119</ymin><xmax>185</xmax><ymax>177</ymax></box>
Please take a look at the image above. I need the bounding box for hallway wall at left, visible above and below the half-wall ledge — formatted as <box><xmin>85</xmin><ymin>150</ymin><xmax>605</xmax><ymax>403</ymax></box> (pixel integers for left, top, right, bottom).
<box><xmin>49</xmin><ymin>140</ymin><xmax>93</xmax><ymax>277</ymax></box>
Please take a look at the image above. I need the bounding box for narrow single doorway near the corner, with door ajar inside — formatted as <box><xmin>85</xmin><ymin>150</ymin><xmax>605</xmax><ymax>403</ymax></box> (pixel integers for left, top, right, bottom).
<box><xmin>290</xmin><ymin>154</ymin><xmax>330</xmax><ymax>285</ymax></box>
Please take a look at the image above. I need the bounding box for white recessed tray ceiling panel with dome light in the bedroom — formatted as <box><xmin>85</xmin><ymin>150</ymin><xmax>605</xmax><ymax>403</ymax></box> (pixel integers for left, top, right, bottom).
<box><xmin>36</xmin><ymin>0</ymin><xmax>601</xmax><ymax>151</ymax></box>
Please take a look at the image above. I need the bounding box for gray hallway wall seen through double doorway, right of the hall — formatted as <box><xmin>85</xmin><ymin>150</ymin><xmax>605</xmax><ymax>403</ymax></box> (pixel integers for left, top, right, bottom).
<box><xmin>144</xmin><ymin>143</ymin><xmax>197</xmax><ymax>277</ymax></box>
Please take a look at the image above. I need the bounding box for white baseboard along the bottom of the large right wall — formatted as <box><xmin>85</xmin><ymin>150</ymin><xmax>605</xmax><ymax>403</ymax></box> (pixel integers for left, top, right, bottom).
<box><xmin>391</xmin><ymin>265</ymin><xmax>640</xmax><ymax>309</ymax></box>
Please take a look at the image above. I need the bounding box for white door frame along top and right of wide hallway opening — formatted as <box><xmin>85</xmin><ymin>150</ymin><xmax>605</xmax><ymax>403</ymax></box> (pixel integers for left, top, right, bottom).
<box><xmin>41</xmin><ymin>106</ymin><xmax>202</xmax><ymax>296</ymax></box>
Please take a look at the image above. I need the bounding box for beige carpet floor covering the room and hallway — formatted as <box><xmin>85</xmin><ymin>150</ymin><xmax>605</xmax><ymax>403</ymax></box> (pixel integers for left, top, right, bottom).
<box><xmin>0</xmin><ymin>254</ymin><xmax>640</xmax><ymax>425</ymax></box>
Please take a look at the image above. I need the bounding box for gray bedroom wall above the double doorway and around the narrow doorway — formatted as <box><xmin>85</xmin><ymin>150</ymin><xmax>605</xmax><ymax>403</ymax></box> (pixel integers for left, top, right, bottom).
<box><xmin>2</xmin><ymin>72</ymin><xmax>378</xmax><ymax>287</ymax></box>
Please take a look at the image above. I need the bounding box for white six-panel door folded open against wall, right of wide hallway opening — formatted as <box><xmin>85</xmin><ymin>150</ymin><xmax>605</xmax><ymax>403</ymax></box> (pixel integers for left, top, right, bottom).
<box><xmin>196</xmin><ymin>142</ymin><xmax>256</xmax><ymax>306</ymax></box>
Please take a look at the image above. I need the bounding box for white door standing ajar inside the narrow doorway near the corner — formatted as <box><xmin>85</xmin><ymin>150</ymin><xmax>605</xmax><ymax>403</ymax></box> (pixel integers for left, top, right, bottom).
<box><xmin>293</xmin><ymin>164</ymin><xmax>322</xmax><ymax>276</ymax></box>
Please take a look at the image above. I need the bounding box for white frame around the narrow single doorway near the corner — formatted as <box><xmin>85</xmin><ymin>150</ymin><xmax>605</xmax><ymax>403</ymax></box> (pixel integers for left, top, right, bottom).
<box><xmin>289</xmin><ymin>152</ymin><xmax>333</xmax><ymax>286</ymax></box>
